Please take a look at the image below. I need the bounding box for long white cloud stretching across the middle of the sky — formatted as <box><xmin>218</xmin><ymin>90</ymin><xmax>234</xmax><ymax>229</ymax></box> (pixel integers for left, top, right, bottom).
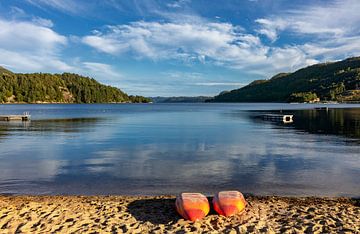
<box><xmin>82</xmin><ymin>21</ymin><xmax>317</xmax><ymax>76</ymax></box>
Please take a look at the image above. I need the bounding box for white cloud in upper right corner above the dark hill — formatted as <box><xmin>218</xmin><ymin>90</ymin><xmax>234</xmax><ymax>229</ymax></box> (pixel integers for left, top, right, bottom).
<box><xmin>255</xmin><ymin>0</ymin><xmax>360</xmax><ymax>68</ymax></box>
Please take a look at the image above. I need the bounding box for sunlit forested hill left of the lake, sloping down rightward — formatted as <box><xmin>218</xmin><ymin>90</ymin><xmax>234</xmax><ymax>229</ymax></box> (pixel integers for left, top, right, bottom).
<box><xmin>0</xmin><ymin>67</ymin><xmax>150</xmax><ymax>103</ymax></box>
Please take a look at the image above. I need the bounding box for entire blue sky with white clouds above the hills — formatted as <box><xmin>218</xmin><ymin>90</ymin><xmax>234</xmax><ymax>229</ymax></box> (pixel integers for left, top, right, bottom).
<box><xmin>0</xmin><ymin>0</ymin><xmax>360</xmax><ymax>96</ymax></box>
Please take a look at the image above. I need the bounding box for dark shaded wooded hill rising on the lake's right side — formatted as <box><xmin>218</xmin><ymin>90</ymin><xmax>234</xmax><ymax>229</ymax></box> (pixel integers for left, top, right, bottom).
<box><xmin>210</xmin><ymin>57</ymin><xmax>360</xmax><ymax>102</ymax></box>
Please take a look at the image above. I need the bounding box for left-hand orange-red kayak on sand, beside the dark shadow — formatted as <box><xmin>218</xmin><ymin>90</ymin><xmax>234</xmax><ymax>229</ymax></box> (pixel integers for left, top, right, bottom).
<box><xmin>175</xmin><ymin>193</ymin><xmax>210</xmax><ymax>221</ymax></box>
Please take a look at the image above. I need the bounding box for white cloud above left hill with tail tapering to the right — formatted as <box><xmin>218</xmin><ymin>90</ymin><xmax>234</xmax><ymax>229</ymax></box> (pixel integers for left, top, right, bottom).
<box><xmin>0</xmin><ymin>18</ymin><xmax>126</xmax><ymax>88</ymax></box>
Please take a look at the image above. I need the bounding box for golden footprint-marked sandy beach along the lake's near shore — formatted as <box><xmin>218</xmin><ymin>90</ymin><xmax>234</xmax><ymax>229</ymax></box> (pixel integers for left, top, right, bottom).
<box><xmin>0</xmin><ymin>196</ymin><xmax>360</xmax><ymax>233</ymax></box>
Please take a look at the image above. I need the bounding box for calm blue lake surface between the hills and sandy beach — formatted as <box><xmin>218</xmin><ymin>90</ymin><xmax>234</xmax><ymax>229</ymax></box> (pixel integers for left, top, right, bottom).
<box><xmin>0</xmin><ymin>103</ymin><xmax>360</xmax><ymax>197</ymax></box>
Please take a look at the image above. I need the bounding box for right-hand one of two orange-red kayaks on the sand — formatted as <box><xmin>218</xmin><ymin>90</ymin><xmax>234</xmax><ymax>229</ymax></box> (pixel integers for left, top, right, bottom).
<box><xmin>213</xmin><ymin>191</ymin><xmax>246</xmax><ymax>216</ymax></box>
